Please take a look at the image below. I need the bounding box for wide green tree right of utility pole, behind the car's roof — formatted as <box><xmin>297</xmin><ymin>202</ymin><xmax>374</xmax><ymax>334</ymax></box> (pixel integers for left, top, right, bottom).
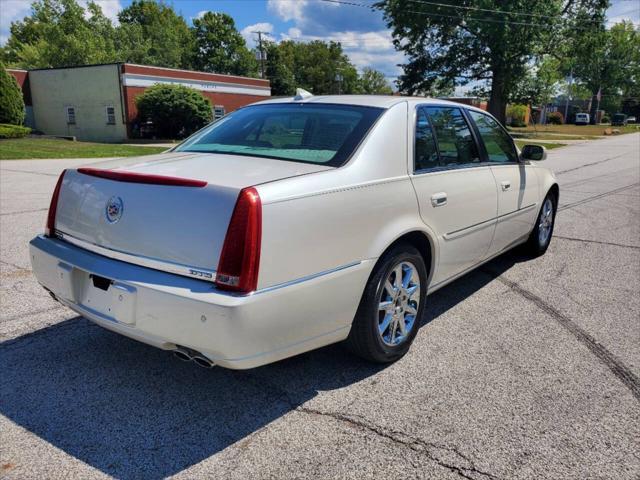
<box><xmin>267</xmin><ymin>40</ymin><xmax>360</xmax><ymax>95</ymax></box>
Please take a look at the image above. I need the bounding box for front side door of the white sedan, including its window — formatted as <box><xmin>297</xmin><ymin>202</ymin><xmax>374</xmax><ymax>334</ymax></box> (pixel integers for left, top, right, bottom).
<box><xmin>467</xmin><ymin>110</ymin><xmax>539</xmax><ymax>255</ymax></box>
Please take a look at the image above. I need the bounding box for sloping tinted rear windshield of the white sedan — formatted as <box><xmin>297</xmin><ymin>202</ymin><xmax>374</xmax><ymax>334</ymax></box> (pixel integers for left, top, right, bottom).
<box><xmin>175</xmin><ymin>103</ymin><xmax>384</xmax><ymax>167</ymax></box>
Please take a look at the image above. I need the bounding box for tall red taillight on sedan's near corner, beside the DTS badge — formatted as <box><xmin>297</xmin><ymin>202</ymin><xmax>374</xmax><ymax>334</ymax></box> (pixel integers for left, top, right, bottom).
<box><xmin>216</xmin><ymin>187</ymin><xmax>262</xmax><ymax>293</ymax></box>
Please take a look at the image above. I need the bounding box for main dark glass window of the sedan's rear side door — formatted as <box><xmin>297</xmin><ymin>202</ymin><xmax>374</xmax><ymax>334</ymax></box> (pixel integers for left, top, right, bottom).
<box><xmin>426</xmin><ymin>107</ymin><xmax>480</xmax><ymax>167</ymax></box>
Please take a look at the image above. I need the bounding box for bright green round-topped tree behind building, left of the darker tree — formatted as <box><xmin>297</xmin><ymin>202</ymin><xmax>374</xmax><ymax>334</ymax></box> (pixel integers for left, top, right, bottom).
<box><xmin>116</xmin><ymin>0</ymin><xmax>194</xmax><ymax>68</ymax></box>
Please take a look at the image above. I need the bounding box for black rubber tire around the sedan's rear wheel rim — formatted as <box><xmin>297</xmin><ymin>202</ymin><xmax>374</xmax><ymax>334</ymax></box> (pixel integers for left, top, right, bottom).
<box><xmin>346</xmin><ymin>244</ymin><xmax>427</xmax><ymax>363</ymax></box>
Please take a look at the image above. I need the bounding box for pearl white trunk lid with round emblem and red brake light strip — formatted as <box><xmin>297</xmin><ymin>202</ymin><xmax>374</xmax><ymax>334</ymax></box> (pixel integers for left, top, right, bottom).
<box><xmin>55</xmin><ymin>153</ymin><xmax>331</xmax><ymax>280</ymax></box>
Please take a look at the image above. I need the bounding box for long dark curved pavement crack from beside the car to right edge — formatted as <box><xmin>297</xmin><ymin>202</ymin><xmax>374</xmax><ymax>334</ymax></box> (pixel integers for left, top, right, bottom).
<box><xmin>481</xmin><ymin>267</ymin><xmax>640</xmax><ymax>401</ymax></box>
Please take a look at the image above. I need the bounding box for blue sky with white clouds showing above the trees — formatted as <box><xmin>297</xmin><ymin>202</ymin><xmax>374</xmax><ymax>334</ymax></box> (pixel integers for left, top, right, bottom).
<box><xmin>0</xmin><ymin>0</ymin><xmax>640</xmax><ymax>87</ymax></box>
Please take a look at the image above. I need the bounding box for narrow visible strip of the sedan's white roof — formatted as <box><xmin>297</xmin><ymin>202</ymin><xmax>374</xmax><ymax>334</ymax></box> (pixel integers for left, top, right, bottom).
<box><xmin>253</xmin><ymin>95</ymin><xmax>484</xmax><ymax>111</ymax></box>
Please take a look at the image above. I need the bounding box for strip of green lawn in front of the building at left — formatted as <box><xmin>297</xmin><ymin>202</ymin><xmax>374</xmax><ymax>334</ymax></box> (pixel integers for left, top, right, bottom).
<box><xmin>0</xmin><ymin>137</ymin><xmax>167</xmax><ymax>160</ymax></box>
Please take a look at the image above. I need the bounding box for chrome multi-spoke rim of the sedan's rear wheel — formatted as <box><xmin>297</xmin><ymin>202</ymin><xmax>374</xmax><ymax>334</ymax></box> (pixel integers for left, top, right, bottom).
<box><xmin>378</xmin><ymin>261</ymin><xmax>420</xmax><ymax>347</ymax></box>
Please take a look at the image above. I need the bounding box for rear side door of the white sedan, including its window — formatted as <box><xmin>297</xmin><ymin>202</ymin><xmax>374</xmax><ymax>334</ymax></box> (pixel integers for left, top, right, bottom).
<box><xmin>411</xmin><ymin>106</ymin><xmax>497</xmax><ymax>286</ymax></box>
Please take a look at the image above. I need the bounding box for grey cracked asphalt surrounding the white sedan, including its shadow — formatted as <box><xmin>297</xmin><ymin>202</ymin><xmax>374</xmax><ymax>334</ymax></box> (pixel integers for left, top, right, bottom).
<box><xmin>0</xmin><ymin>134</ymin><xmax>640</xmax><ymax>480</ymax></box>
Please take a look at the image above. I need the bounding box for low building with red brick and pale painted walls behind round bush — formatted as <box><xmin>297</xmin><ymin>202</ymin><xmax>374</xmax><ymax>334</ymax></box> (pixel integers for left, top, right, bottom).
<box><xmin>8</xmin><ymin>63</ymin><xmax>271</xmax><ymax>142</ymax></box>
